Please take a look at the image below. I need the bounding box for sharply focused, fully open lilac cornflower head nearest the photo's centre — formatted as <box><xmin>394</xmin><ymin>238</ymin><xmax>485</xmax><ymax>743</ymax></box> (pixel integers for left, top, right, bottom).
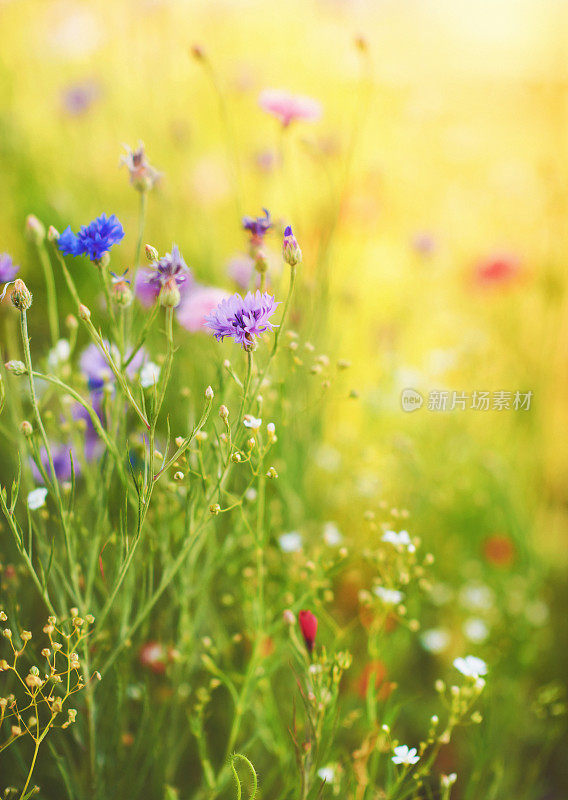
<box><xmin>205</xmin><ymin>291</ymin><xmax>278</xmax><ymax>350</ymax></box>
